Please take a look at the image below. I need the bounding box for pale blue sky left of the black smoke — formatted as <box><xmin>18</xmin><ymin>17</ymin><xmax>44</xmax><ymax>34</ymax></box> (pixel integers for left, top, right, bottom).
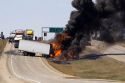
<box><xmin>0</xmin><ymin>0</ymin><xmax>73</xmax><ymax>36</ymax></box>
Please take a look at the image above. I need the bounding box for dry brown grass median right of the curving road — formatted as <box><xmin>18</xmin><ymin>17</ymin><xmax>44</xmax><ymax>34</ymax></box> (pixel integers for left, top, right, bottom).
<box><xmin>49</xmin><ymin>57</ymin><xmax>125</xmax><ymax>81</ymax></box>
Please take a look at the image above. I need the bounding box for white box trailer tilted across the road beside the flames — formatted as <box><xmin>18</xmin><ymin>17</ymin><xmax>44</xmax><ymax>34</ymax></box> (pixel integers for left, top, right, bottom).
<box><xmin>18</xmin><ymin>40</ymin><xmax>50</xmax><ymax>55</ymax></box>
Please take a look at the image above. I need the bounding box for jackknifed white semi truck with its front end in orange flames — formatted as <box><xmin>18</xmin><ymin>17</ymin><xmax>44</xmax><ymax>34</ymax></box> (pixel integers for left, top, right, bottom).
<box><xmin>19</xmin><ymin>34</ymin><xmax>71</xmax><ymax>58</ymax></box>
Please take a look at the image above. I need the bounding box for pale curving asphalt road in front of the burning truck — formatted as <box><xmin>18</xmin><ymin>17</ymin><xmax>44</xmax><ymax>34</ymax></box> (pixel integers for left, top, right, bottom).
<box><xmin>0</xmin><ymin>44</ymin><xmax>121</xmax><ymax>83</ymax></box>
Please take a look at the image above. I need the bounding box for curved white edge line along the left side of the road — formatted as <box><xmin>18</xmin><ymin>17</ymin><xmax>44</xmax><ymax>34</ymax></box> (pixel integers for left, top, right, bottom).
<box><xmin>11</xmin><ymin>55</ymin><xmax>41</xmax><ymax>83</ymax></box>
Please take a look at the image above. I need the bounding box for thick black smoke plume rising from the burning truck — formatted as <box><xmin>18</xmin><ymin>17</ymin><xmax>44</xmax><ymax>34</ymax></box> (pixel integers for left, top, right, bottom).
<box><xmin>55</xmin><ymin>0</ymin><xmax>125</xmax><ymax>61</ymax></box>
